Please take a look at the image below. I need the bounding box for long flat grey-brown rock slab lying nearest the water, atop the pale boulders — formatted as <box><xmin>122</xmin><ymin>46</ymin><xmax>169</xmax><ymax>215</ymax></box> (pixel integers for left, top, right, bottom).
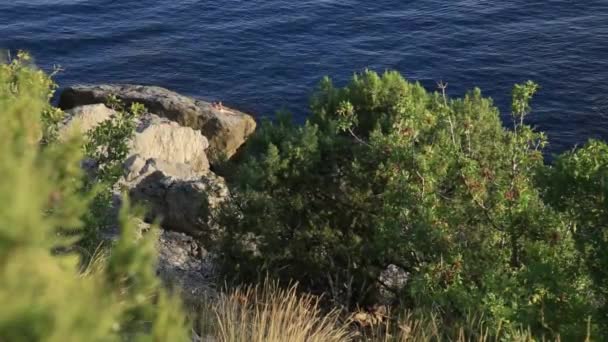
<box><xmin>59</xmin><ymin>84</ymin><xmax>256</xmax><ymax>163</ymax></box>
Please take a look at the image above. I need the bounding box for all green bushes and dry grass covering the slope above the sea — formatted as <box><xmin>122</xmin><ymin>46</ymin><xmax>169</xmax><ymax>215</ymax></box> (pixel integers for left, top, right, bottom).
<box><xmin>0</xmin><ymin>54</ymin><xmax>608</xmax><ymax>341</ymax></box>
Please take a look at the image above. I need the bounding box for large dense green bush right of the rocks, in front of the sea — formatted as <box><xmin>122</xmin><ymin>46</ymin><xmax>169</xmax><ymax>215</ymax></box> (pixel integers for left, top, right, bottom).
<box><xmin>209</xmin><ymin>71</ymin><xmax>606</xmax><ymax>338</ymax></box>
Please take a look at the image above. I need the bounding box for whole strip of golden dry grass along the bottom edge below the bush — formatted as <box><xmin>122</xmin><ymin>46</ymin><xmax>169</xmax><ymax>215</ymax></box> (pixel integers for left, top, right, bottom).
<box><xmin>196</xmin><ymin>281</ymin><xmax>591</xmax><ymax>342</ymax></box>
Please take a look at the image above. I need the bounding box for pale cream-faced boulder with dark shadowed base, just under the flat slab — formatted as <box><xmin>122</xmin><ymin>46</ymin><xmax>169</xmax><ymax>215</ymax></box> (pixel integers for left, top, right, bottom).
<box><xmin>60</xmin><ymin>104</ymin><xmax>228</xmax><ymax>236</ymax></box>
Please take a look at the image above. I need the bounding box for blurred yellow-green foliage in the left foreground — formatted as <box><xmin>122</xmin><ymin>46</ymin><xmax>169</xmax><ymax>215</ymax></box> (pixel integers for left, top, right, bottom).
<box><xmin>0</xmin><ymin>55</ymin><xmax>188</xmax><ymax>341</ymax></box>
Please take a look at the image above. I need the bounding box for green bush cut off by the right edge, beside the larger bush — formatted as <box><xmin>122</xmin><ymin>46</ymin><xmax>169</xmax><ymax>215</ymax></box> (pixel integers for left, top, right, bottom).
<box><xmin>541</xmin><ymin>140</ymin><xmax>608</xmax><ymax>331</ymax></box>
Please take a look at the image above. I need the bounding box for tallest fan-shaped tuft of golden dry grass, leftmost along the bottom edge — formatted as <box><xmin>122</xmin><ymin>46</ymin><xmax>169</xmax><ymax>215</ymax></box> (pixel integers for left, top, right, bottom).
<box><xmin>203</xmin><ymin>281</ymin><xmax>352</xmax><ymax>342</ymax></box>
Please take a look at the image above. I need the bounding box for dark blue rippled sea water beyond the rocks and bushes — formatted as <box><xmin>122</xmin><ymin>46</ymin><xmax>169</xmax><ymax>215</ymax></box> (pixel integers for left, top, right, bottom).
<box><xmin>0</xmin><ymin>0</ymin><xmax>608</xmax><ymax>151</ymax></box>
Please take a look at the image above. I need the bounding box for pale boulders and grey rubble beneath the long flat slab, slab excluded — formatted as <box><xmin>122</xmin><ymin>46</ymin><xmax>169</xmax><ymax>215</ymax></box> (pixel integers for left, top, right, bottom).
<box><xmin>59</xmin><ymin>104</ymin><xmax>228</xmax><ymax>320</ymax></box>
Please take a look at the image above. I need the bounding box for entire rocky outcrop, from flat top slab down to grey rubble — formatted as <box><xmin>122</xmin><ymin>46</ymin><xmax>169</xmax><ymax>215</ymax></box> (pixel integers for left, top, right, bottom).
<box><xmin>58</xmin><ymin>84</ymin><xmax>256</xmax><ymax>307</ymax></box>
